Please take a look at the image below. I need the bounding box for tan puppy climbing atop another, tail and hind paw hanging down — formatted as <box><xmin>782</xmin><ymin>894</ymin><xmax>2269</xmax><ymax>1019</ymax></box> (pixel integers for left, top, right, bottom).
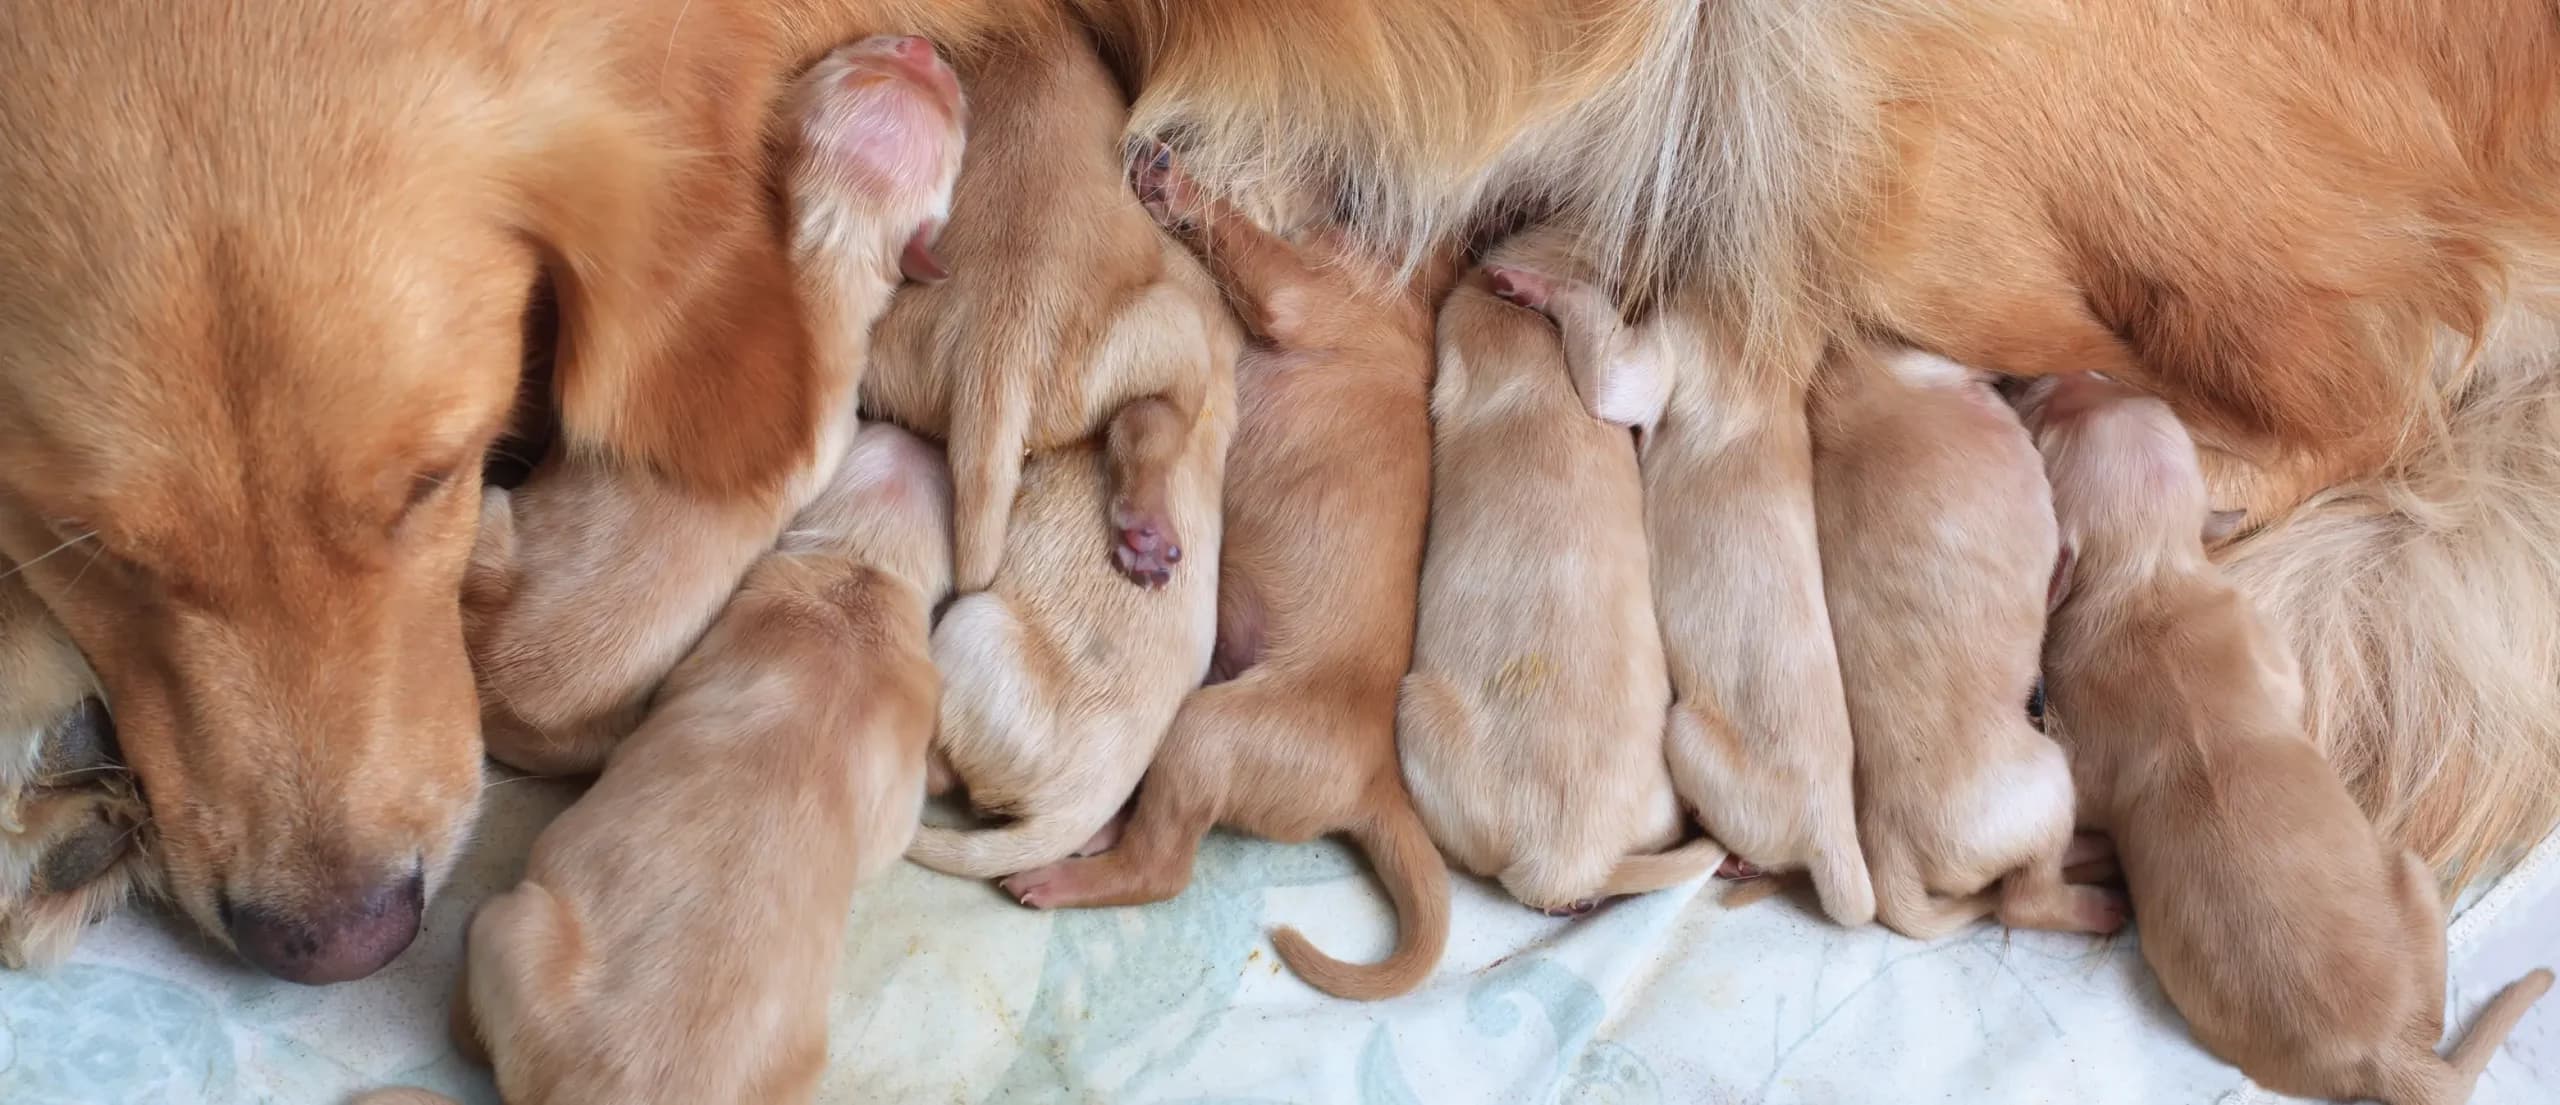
<box><xmin>863</xmin><ymin>23</ymin><xmax>1211</xmax><ymax>593</ymax></box>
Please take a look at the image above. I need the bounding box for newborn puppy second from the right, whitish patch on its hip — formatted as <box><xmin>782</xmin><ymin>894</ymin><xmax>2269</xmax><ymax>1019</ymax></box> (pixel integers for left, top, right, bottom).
<box><xmin>1812</xmin><ymin>350</ymin><xmax>2125</xmax><ymax>939</ymax></box>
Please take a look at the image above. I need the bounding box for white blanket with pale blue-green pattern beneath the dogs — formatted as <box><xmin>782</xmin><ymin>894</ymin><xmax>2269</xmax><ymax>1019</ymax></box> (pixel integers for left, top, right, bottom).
<box><xmin>0</xmin><ymin>780</ymin><xmax>2560</xmax><ymax>1105</ymax></box>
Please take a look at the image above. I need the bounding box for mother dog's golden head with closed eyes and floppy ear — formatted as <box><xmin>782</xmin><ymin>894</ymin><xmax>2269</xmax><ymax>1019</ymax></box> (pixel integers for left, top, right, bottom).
<box><xmin>0</xmin><ymin>0</ymin><xmax>804</xmax><ymax>982</ymax></box>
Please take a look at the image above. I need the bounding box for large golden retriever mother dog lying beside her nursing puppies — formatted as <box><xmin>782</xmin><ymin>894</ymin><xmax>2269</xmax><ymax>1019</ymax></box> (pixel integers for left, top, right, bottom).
<box><xmin>0</xmin><ymin>0</ymin><xmax>2560</xmax><ymax>982</ymax></box>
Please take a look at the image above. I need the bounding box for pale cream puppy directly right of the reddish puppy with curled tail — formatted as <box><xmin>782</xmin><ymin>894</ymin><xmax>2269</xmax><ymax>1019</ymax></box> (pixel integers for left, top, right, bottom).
<box><xmin>1398</xmin><ymin>230</ymin><xmax>1725</xmax><ymax>913</ymax></box>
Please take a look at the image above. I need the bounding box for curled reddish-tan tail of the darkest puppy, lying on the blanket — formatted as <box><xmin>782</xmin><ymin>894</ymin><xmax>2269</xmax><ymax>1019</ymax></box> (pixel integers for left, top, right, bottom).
<box><xmin>1272</xmin><ymin>778</ymin><xmax>1449</xmax><ymax>1000</ymax></box>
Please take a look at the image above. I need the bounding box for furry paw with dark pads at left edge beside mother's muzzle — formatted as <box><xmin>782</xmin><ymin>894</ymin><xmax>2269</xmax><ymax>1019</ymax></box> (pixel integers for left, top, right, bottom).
<box><xmin>0</xmin><ymin>578</ymin><xmax>159</xmax><ymax>969</ymax></box>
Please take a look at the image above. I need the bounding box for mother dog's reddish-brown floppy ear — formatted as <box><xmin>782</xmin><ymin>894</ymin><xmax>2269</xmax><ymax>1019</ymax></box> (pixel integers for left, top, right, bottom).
<box><xmin>501</xmin><ymin>110</ymin><xmax>819</xmax><ymax>496</ymax></box>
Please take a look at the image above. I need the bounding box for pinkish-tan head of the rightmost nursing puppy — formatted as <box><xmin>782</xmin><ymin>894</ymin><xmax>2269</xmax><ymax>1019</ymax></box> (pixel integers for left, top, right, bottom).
<box><xmin>2017</xmin><ymin>373</ymin><xmax>2227</xmax><ymax>572</ymax></box>
